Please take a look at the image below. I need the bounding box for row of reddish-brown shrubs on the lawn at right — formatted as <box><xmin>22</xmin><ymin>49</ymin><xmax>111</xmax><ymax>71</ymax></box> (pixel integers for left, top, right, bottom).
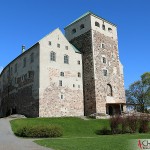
<box><xmin>98</xmin><ymin>115</ymin><xmax>150</xmax><ymax>135</ymax></box>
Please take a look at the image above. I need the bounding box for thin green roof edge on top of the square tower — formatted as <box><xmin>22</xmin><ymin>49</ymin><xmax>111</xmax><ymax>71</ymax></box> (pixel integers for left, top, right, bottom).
<box><xmin>65</xmin><ymin>11</ymin><xmax>116</xmax><ymax>29</ymax></box>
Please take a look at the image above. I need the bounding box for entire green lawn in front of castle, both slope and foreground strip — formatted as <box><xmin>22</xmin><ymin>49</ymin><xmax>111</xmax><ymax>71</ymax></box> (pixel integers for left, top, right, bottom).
<box><xmin>11</xmin><ymin>118</ymin><xmax>150</xmax><ymax>150</ymax></box>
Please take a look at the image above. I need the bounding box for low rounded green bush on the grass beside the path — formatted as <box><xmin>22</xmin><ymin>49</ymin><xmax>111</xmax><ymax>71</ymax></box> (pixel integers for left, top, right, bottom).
<box><xmin>15</xmin><ymin>125</ymin><xmax>63</xmax><ymax>138</ymax></box>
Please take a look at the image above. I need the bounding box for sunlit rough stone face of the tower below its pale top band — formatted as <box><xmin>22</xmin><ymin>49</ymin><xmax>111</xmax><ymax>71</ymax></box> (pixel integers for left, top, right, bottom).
<box><xmin>93</xmin><ymin>31</ymin><xmax>125</xmax><ymax>113</ymax></box>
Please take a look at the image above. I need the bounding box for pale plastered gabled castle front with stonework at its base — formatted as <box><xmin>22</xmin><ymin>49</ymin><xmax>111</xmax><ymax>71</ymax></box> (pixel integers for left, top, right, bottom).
<box><xmin>39</xmin><ymin>29</ymin><xmax>84</xmax><ymax>117</ymax></box>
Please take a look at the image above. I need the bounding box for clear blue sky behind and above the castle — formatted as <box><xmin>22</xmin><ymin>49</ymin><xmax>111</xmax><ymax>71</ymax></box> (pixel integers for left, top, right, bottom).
<box><xmin>0</xmin><ymin>0</ymin><xmax>150</xmax><ymax>88</ymax></box>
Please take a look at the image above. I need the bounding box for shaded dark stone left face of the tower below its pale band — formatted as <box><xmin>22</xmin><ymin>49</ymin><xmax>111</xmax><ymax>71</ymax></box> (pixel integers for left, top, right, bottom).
<box><xmin>70</xmin><ymin>30</ymin><xmax>96</xmax><ymax>115</ymax></box>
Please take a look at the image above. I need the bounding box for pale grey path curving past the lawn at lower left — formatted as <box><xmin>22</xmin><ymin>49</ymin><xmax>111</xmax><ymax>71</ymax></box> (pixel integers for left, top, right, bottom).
<box><xmin>0</xmin><ymin>118</ymin><xmax>52</xmax><ymax>150</ymax></box>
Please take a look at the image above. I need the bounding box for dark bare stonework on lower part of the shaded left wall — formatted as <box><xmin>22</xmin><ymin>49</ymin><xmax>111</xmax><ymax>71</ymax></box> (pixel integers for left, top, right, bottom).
<box><xmin>0</xmin><ymin>74</ymin><xmax>39</xmax><ymax>117</ymax></box>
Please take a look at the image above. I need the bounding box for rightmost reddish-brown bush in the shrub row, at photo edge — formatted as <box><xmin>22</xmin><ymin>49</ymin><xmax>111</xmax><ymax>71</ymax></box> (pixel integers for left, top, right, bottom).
<box><xmin>139</xmin><ymin>116</ymin><xmax>149</xmax><ymax>133</ymax></box>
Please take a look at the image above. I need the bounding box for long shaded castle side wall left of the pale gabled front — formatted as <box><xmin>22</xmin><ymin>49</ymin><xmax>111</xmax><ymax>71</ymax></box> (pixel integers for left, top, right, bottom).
<box><xmin>0</xmin><ymin>45</ymin><xmax>39</xmax><ymax>117</ymax></box>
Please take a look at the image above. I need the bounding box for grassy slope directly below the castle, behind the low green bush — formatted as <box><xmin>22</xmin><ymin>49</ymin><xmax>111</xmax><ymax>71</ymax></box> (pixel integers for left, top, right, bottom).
<box><xmin>11</xmin><ymin>118</ymin><xmax>109</xmax><ymax>137</ymax></box>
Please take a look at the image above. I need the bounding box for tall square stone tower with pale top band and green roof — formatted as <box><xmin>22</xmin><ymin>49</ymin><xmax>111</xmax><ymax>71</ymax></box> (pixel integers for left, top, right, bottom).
<box><xmin>65</xmin><ymin>12</ymin><xmax>125</xmax><ymax>115</ymax></box>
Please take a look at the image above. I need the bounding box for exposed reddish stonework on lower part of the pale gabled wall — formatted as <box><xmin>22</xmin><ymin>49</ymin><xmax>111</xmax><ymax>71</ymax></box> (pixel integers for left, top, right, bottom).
<box><xmin>40</xmin><ymin>68</ymin><xmax>83</xmax><ymax>117</ymax></box>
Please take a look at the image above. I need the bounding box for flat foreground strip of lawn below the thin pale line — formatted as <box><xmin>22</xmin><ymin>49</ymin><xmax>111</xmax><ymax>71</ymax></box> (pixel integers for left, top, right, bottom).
<box><xmin>35</xmin><ymin>134</ymin><xmax>150</xmax><ymax>150</ymax></box>
